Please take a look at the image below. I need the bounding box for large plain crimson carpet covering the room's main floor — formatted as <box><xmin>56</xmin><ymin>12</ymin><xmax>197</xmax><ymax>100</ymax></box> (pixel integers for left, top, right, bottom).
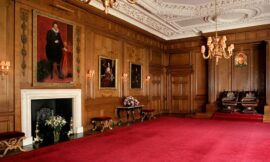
<box><xmin>0</xmin><ymin>117</ymin><xmax>270</xmax><ymax>162</ymax></box>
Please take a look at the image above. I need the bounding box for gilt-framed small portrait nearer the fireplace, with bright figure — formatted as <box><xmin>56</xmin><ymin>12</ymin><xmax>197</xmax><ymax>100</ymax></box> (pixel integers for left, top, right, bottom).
<box><xmin>99</xmin><ymin>56</ymin><xmax>117</xmax><ymax>89</ymax></box>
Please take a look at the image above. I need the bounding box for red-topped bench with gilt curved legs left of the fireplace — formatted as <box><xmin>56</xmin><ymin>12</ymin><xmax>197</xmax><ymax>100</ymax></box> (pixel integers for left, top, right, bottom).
<box><xmin>0</xmin><ymin>131</ymin><xmax>26</xmax><ymax>157</ymax></box>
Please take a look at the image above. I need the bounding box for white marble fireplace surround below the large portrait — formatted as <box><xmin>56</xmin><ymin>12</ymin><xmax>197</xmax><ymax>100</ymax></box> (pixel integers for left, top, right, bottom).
<box><xmin>21</xmin><ymin>89</ymin><xmax>83</xmax><ymax>146</ymax></box>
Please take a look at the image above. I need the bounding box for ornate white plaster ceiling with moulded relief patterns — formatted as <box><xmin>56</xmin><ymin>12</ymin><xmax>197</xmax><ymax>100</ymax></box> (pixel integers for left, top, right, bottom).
<box><xmin>84</xmin><ymin>0</ymin><xmax>270</xmax><ymax>40</ymax></box>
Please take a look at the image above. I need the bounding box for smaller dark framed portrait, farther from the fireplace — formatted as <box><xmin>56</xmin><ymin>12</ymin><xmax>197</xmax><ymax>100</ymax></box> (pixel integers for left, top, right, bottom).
<box><xmin>130</xmin><ymin>63</ymin><xmax>142</xmax><ymax>88</ymax></box>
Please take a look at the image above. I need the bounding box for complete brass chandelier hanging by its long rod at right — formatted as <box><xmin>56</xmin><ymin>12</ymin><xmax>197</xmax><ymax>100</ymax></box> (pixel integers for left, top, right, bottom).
<box><xmin>201</xmin><ymin>0</ymin><xmax>234</xmax><ymax>65</ymax></box>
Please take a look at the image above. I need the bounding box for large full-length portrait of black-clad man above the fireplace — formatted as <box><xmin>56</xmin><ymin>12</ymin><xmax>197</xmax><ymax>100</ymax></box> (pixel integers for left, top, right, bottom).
<box><xmin>33</xmin><ymin>11</ymin><xmax>75</xmax><ymax>86</ymax></box>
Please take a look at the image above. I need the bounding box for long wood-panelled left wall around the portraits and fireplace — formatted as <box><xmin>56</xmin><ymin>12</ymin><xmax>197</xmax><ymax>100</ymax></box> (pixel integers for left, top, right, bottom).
<box><xmin>0</xmin><ymin>0</ymin><xmax>167</xmax><ymax>132</ymax></box>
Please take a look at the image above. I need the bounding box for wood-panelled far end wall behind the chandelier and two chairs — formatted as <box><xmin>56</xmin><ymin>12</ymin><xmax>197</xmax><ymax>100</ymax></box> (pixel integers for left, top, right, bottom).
<box><xmin>166</xmin><ymin>25</ymin><xmax>270</xmax><ymax>113</ymax></box>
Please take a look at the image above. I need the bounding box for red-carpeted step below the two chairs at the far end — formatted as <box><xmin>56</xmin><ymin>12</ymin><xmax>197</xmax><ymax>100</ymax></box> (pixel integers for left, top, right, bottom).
<box><xmin>212</xmin><ymin>112</ymin><xmax>263</xmax><ymax>122</ymax></box>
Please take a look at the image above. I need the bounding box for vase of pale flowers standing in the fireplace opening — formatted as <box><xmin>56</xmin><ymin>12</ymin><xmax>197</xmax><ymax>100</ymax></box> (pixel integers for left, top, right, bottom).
<box><xmin>45</xmin><ymin>116</ymin><xmax>67</xmax><ymax>142</ymax></box>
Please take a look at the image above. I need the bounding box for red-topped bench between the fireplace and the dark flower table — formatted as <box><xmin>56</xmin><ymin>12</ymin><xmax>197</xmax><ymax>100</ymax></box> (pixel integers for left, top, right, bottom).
<box><xmin>91</xmin><ymin>116</ymin><xmax>112</xmax><ymax>132</ymax></box>
